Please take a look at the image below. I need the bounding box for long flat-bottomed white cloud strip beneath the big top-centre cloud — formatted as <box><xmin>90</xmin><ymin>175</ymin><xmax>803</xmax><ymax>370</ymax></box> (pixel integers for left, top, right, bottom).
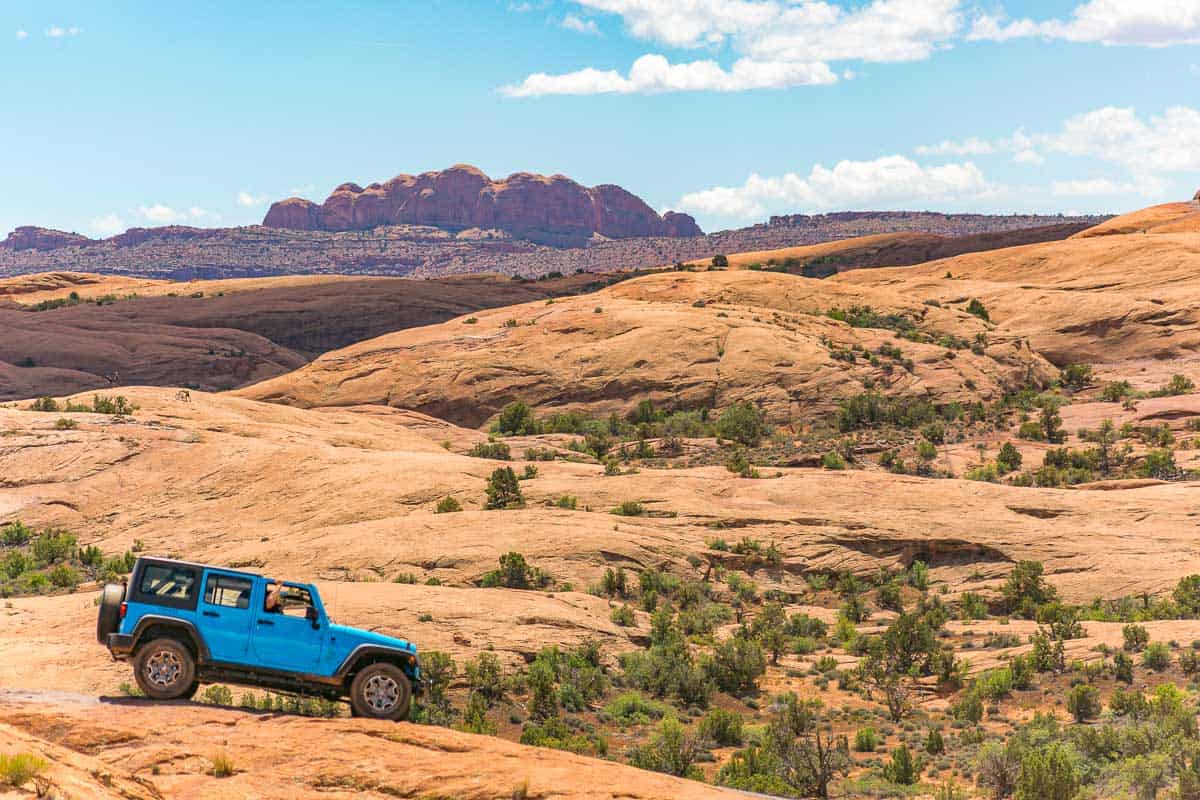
<box><xmin>500</xmin><ymin>55</ymin><xmax>838</xmax><ymax>97</ymax></box>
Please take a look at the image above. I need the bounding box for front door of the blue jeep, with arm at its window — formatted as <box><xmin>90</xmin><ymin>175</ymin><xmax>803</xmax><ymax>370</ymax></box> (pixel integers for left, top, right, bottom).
<box><xmin>252</xmin><ymin>583</ymin><xmax>329</xmax><ymax>673</ymax></box>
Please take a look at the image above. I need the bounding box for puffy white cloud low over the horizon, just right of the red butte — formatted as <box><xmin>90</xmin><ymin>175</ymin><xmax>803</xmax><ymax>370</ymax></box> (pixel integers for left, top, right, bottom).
<box><xmin>677</xmin><ymin>156</ymin><xmax>997</xmax><ymax>218</ymax></box>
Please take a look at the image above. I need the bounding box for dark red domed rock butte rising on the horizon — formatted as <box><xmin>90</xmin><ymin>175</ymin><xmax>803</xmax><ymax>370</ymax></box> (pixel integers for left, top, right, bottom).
<box><xmin>263</xmin><ymin>164</ymin><xmax>703</xmax><ymax>246</ymax></box>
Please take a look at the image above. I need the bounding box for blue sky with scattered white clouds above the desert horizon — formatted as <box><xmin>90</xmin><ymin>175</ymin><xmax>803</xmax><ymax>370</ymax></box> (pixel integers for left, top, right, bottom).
<box><xmin>0</xmin><ymin>0</ymin><xmax>1200</xmax><ymax>235</ymax></box>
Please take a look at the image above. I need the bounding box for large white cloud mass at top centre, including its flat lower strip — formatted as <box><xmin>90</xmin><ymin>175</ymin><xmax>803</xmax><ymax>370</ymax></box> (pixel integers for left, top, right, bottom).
<box><xmin>502</xmin><ymin>0</ymin><xmax>965</xmax><ymax>97</ymax></box>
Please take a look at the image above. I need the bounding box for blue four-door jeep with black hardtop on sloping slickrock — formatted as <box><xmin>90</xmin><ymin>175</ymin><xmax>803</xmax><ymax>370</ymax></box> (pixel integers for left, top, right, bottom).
<box><xmin>96</xmin><ymin>558</ymin><xmax>421</xmax><ymax>720</ymax></box>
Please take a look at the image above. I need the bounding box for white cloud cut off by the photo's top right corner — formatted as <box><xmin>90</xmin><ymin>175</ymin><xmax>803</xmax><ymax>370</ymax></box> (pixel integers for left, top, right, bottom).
<box><xmin>967</xmin><ymin>0</ymin><xmax>1200</xmax><ymax>47</ymax></box>
